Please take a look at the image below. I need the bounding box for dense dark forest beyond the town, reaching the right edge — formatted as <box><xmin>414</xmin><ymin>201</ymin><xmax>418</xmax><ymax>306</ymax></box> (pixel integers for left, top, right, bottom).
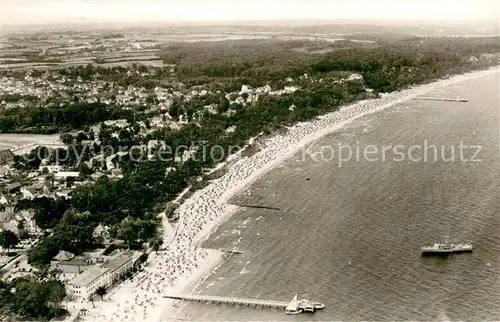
<box><xmin>162</xmin><ymin>35</ymin><xmax>500</xmax><ymax>91</ymax></box>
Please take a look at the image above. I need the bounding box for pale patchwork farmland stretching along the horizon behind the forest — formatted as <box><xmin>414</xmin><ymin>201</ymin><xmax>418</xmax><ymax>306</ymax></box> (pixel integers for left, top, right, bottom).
<box><xmin>0</xmin><ymin>24</ymin><xmax>498</xmax><ymax>70</ymax></box>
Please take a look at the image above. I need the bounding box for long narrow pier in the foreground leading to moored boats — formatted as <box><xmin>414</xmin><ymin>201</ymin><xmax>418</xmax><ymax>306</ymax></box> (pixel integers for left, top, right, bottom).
<box><xmin>163</xmin><ymin>294</ymin><xmax>289</xmax><ymax>310</ymax></box>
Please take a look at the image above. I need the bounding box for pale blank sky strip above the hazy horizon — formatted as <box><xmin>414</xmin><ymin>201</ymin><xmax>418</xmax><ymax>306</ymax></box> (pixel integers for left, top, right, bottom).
<box><xmin>0</xmin><ymin>0</ymin><xmax>500</xmax><ymax>24</ymax></box>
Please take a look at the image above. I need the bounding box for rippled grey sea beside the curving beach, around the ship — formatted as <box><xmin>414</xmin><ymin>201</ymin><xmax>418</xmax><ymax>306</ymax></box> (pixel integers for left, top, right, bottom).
<box><xmin>172</xmin><ymin>71</ymin><xmax>500</xmax><ymax>321</ymax></box>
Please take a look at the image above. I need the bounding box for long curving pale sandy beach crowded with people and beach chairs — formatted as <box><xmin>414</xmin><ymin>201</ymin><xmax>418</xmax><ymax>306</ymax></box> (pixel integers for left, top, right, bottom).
<box><xmin>74</xmin><ymin>67</ymin><xmax>500</xmax><ymax>321</ymax></box>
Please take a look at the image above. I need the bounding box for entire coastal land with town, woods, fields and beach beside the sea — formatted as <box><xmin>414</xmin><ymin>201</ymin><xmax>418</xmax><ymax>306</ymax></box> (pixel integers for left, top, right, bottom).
<box><xmin>0</xmin><ymin>21</ymin><xmax>500</xmax><ymax>321</ymax></box>
